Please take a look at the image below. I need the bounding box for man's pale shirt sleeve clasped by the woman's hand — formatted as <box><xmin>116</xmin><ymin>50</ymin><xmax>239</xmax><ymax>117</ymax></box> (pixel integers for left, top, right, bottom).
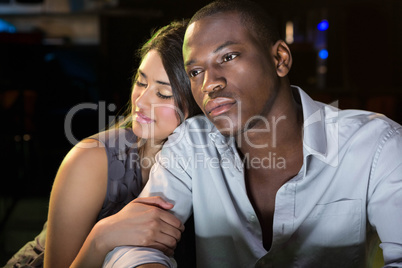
<box><xmin>103</xmin><ymin>127</ymin><xmax>192</xmax><ymax>268</ymax></box>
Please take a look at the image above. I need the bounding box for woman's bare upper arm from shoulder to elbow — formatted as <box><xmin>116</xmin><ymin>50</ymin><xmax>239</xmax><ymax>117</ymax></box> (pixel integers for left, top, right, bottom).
<box><xmin>44</xmin><ymin>140</ymin><xmax>107</xmax><ymax>268</ymax></box>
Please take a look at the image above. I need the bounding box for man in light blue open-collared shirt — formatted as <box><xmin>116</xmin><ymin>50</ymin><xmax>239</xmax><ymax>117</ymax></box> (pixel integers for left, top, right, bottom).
<box><xmin>105</xmin><ymin>1</ymin><xmax>402</xmax><ymax>267</ymax></box>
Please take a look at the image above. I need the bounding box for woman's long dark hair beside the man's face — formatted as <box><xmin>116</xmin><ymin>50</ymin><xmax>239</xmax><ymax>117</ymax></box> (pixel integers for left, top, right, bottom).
<box><xmin>111</xmin><ymin>20</ymin><xmax>201</xmax><ymax>130</ymax></box>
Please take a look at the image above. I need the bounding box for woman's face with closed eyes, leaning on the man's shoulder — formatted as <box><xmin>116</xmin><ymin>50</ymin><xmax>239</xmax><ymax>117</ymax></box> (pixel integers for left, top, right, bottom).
<box><xmin>131</xmin><ymin>50</ymin><xmax>180</xmax><ymax>144</ymax></box>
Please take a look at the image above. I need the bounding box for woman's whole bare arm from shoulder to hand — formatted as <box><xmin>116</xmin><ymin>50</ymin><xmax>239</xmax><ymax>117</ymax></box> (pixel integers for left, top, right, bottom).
<box><xmin>45</xmin><ymin>140</ymin><xmax>184</xmax><ymax>268</ymax></box>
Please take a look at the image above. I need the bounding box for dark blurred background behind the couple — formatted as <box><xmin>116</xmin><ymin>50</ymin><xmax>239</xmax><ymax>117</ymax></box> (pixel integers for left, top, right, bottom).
<box><xmin>0</xmin><ymin>0</ymin><xmax>402</xmax><ymax>265</ymax></box>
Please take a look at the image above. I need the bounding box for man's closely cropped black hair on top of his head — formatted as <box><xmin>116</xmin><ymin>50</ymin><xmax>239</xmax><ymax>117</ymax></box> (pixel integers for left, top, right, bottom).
<box><xmin>189</xmin><ymin>0</ymin><xmax>280</xmax><ymax>46</ymax></box>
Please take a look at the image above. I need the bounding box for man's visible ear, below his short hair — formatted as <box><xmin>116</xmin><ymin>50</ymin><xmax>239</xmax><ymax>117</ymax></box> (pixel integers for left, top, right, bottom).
<box><xmin>272</xmin><ymin>40</ymin><xmax>292</xmax><ymax>77</ymax></box>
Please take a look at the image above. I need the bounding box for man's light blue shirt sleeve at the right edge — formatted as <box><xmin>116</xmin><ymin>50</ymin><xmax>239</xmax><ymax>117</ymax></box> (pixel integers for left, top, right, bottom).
<box><xmin>367</xmin><ymin>125</ymin><xmax>402</xmax><ymax>267</ymax></box>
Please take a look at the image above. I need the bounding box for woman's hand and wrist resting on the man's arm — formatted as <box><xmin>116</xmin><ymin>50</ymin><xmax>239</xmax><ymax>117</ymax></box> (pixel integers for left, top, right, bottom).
<box><xmin>93</xmin><ymin>196</ymin><xmax>184</xmax><ymax>256</ymax></box>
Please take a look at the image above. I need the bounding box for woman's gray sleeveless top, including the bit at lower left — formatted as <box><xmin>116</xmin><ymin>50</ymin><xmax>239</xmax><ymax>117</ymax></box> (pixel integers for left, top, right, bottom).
<box><xmin>3</xmin><ymin>128</ymin><xmax>142</xmax><ymax>268</ymax></box>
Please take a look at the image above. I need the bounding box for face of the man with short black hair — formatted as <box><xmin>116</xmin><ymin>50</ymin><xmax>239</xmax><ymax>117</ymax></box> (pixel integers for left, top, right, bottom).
<box><xmin>183</xmin><ymin>12</ymin><xmax>279</xmax><ymax>136</ymax></box>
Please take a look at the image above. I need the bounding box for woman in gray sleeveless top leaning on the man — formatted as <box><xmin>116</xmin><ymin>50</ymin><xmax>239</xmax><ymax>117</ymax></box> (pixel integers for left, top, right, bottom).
<box><xmin>6</xmin><ymin>22</ymin><xmax>200</xmax><ymax>268</ymax></box>
